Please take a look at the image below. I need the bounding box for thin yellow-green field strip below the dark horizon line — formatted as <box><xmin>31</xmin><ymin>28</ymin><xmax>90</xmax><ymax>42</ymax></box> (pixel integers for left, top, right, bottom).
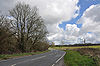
<box><xmin>52</xmin><ymin>45</ymin><xmax>100</xmax><ymax>50</ymax></box>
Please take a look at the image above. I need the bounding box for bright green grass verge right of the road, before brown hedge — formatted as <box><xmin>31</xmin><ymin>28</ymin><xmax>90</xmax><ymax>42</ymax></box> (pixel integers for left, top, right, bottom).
<box><xmin>64</xmin><ymin>50</ymin><xmax>97</xmax><ymax>66</ymax></box>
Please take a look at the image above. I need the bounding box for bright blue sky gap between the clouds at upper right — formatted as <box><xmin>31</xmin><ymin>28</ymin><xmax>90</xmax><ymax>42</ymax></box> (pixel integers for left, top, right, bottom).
<box><xmin>59</xmin><ymin>0</ymin><xmax>100</xmax><ymax>30</ymax></box>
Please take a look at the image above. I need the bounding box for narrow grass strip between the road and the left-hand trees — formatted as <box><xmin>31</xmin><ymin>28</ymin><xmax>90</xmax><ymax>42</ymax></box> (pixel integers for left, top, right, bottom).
<box><xmin>0</xmin><ymin>50</ymin><xmax>49</xmax><ymax>60</ymax></box>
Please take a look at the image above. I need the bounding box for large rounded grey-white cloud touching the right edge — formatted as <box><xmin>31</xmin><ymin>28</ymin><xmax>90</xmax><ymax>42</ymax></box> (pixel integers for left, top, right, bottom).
<box><xmin>78</xmin><ymin>4</ymin><xmax>100</xmax><ymax>42</ymax></box>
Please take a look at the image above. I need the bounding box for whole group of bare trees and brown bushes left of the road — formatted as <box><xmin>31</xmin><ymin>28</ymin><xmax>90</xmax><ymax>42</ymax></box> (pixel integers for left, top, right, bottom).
<box><xmin>0</xmin><ymin>3</ymin><xmax>49</xmax><ymax>54</ymax></box>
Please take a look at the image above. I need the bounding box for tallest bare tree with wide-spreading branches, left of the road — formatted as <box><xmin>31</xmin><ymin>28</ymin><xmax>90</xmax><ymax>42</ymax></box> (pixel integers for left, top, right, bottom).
<box><xmin>9</xmin><ymin>3</ymin><xmax>48</xmax><ymax>52</ymax></box>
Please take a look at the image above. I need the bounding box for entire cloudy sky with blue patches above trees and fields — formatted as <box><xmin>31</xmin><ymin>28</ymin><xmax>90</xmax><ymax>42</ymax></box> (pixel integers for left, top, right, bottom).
<box><xmin>0</xmin><ymin>0</ymin><xmax>100</xmax><ymax>45</ymax></box>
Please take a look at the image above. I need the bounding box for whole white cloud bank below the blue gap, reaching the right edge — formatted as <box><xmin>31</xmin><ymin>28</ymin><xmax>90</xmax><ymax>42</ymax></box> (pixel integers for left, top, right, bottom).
<box><xmin>51</xmin><ymin>5</ymin><xmax>100</xmax><ymax>44</ymax></box>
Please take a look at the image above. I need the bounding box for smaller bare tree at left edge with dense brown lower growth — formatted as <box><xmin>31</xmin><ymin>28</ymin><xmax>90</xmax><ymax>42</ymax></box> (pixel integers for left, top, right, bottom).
<box><xmin>0</xmin><ymin>16</ymin><xmax>16</xmax><ymax>54</ymax></box>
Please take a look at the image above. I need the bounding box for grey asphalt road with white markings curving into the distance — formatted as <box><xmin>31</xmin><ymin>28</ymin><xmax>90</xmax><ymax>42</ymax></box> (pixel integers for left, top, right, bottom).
<box><xmin>0</xmin><ymin>50</ymin><xmax>65</xmax><ymax>66</ymax></box>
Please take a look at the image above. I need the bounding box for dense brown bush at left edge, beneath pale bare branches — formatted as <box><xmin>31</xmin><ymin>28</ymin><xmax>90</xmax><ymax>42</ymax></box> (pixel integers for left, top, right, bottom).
<box><xmin>0</xmin><ymin>28</ymin><xmax>17</xmax><ymax>54</ymax></box>
